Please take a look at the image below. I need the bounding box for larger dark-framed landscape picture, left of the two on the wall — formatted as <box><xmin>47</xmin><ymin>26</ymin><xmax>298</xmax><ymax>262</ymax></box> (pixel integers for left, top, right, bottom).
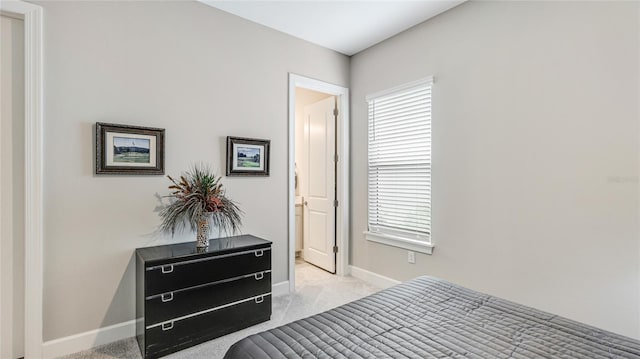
<box><xmin>96</xmin><ymin>122</ymin><xmax>164</xmax><ymax>175</ymax></box>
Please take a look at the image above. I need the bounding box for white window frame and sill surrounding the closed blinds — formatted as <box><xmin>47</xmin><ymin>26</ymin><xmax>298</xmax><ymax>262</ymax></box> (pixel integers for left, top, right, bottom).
<box><xmin>364</xmin><ymin>76</ymin><xmax>434</xmax><ymax>254</ymax></box>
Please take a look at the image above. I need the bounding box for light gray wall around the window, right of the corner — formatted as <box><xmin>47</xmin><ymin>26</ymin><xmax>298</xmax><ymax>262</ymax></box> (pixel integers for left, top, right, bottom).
<box><xmin>351</xmin><ymin>1</ymin><xmax>640</xmax><ymax>338</ymax></box>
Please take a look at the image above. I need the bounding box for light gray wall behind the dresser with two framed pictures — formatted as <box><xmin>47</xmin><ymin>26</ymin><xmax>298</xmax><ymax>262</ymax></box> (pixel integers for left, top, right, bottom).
<box><xmin>39</xmin><ymin>1</ymin><xmax>349</xmax><ymax>340</ymax></box>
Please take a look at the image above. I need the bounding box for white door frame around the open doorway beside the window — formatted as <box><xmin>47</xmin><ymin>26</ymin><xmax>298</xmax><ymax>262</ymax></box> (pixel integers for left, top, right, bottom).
<box><xmin>287</xmin><ymin>73</ymin><xmax>349</xmax><ymax>293</ymax></box>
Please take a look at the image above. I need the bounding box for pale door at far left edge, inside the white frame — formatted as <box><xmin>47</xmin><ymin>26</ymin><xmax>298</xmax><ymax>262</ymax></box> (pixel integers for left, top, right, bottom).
<box><xmin>0</xmin><ymin>15</ymin><xmax>24</xmax><ymax>359</ymax></box>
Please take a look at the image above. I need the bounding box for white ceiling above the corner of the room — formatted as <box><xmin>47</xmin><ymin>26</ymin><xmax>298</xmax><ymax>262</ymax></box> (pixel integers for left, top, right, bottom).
<box><xmin>199</xmin><ymin>0</ymin><xmax>466</xmax><ymax>55</ymax></box>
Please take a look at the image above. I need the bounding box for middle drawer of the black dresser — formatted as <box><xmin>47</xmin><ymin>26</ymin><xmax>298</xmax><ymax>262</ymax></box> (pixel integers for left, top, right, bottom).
<box><xmin>145</xmin><ymin>272</ymin><xmax>271</xmax><ymax>326</ymax></box>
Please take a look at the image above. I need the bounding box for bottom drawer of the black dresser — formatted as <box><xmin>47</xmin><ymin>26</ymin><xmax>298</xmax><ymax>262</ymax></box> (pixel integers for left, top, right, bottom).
<box><xmin>145</xmin><ymin>295</ymin><xmax>271</xmax><ymax>358</ymax></box>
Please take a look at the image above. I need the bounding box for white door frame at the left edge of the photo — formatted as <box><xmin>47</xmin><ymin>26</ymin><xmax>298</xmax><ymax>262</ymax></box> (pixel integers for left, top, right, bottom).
<box><xmin>0</xmin><ymin>0</ymin><xmax>44</xmax><ymax>359</ymax></box>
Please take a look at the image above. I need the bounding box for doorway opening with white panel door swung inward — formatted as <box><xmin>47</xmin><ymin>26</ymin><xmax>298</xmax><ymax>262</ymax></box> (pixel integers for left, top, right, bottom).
<box><xmin>294</xmin><ymin>87</ymin><xmax>339</xmax><ymax>274</ymax></box>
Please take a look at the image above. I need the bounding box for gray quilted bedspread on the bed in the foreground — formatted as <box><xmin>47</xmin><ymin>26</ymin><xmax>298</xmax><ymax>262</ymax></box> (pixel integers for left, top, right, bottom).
<box><xmin>225</xmin><ymin>277</ymin><xmax>640</xmax><ymax>359</ymax></box>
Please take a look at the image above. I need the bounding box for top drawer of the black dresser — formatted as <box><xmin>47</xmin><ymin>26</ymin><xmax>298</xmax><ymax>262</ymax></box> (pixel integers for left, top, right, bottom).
<box><xmin>145</xmin><ymin>248</ymin><xmax>271</xmax><ymax>297</ymax></box>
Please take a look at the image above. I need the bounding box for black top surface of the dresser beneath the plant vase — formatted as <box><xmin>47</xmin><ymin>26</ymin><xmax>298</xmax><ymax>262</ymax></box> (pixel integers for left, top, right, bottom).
<box><xmin>136</xmin><ymin>234</ymin><xmax>271</xmax><ymax>262</ymax></box>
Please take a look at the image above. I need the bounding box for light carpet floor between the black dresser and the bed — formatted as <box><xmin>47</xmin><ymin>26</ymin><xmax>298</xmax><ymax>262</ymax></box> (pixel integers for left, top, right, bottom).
<box><xmin>61</xmin><ymin>260</ymin><xmax>380</xmax><ymax>359</ymax></box>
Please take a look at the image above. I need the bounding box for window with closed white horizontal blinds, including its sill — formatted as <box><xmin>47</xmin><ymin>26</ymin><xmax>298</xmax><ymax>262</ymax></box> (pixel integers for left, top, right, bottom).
<box><xmin>366</xmin><ymin>78</ymin><xmax>433</xmax><ymax>254</ymax></box>
